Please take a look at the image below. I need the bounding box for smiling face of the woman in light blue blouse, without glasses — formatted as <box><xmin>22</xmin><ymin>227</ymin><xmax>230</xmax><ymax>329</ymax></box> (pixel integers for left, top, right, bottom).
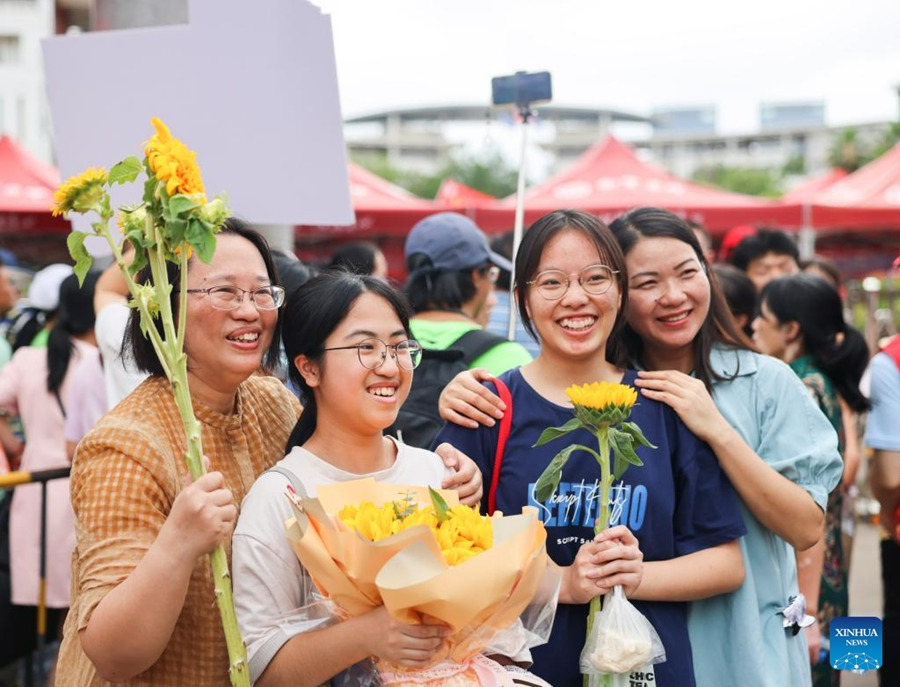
<box><xmin>625</xmin><ymin>237</ymin><xmax>710</xmax><ymax>372</ymax></box>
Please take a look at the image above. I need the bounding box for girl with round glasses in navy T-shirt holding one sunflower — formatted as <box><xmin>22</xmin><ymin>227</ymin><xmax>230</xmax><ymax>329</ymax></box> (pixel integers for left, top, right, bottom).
<box><xmin>430</xmin><ymin>210</ymin><xmax>745</xmax><ymax>687</ymax></box>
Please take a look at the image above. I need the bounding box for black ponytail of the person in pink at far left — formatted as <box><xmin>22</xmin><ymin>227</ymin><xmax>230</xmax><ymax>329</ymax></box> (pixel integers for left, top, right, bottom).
<box><xmin>47</xmin><ymin>272</ymin><xmax>99</xmax><ymax>403</ymax></box>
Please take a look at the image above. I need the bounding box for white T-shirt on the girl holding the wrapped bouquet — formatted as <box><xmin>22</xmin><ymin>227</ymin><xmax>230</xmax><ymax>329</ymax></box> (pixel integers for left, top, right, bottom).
<box><xmin>231</xmin><ymin>440</ymin><xmax>452</xmax><ymax>681</ymax></box>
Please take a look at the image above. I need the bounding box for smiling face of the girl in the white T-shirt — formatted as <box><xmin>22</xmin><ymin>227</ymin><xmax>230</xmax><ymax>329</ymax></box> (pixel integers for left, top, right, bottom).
<box><xmin>304</xmin><ymin>292</ymin><xmax>413</xmax><ymax>435</ymax></box>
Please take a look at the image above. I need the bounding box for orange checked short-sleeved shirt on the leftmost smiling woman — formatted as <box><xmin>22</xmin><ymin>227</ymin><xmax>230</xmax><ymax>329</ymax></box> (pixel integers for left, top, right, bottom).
<box><xmin>57</xmin><ymin>377</ymin><xmax>300</xmax><ymax>687</ymax></box>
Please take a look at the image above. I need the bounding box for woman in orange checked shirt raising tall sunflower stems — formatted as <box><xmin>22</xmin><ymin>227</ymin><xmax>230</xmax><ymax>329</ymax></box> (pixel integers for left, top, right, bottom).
<box><xmin>58</xmin><ymin>219</ymin><xmax>300</xmax><ymax>687</ymax></box>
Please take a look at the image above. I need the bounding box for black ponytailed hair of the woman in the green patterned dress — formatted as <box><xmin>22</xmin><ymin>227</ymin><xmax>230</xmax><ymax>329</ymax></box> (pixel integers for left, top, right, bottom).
<box><xmin>759</xmin><ymin>274</ymin><xmax>869</xmax><ymax>413</ymax></box>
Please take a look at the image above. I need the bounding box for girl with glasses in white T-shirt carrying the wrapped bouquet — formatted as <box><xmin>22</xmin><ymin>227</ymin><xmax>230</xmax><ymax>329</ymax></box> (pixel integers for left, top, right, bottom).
<box><xmin>233</xmin><ymin>271</ymin><xmax>510</xmax><ymax>687</ymax></box>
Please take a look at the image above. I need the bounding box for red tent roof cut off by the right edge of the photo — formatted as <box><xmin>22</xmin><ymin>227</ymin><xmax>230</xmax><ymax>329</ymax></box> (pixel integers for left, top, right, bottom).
<box><xmin>810</xmin><ymin>145</ymin><xmax>900</xmax><ymax>228</ymax></box>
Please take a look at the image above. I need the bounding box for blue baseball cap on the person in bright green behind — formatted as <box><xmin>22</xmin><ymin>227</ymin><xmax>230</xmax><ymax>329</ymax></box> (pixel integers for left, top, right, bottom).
<box><xmin>403</xmin><ymin>212</ymin><xmax>512</xmax><ymax>272</ymax></box>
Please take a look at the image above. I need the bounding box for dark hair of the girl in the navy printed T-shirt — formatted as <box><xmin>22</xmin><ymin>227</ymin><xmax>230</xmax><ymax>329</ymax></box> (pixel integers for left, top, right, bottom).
<box><xmin>516</xmin><ymin>210</ymin><xmax>628</xmax><ymax>358</ymax></box>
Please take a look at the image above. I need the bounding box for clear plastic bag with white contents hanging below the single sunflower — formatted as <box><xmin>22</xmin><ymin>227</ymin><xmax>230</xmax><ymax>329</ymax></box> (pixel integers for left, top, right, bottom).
<box><xmin>581</xmin><ymin>586</ymin><xmax>666</xmax><ymax>675</ymax></box>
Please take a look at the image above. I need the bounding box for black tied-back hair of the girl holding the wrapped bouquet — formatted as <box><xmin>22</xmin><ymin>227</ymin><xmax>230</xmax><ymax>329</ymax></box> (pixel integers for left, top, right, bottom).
<box><xmin>282</xmin><ymin>270</ymin><xmax>412</xmax><ymax>453</ymax></box>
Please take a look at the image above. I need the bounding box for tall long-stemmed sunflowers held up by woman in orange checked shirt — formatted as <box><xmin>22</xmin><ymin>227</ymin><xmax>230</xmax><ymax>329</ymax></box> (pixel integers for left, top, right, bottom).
<box><xmin>53</xmin><ymin>118</ymin><xmax>250</xmax><ymax>687</ymax></box>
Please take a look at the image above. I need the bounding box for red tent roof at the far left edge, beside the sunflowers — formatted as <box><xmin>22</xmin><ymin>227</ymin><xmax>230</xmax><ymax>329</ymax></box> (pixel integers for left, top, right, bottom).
<box><xmin>0</xmin><ymin>136</ymin><xmax>59</xmax><ymax>212</ymax></box>
